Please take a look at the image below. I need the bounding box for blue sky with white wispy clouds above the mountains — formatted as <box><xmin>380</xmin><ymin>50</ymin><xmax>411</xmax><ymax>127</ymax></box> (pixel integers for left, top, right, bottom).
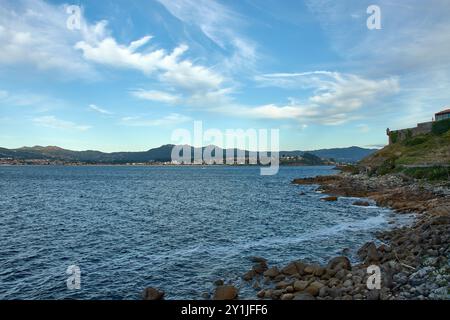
<box><xmin>0</xmin><ymin>0</ymin><xmax>450</xmax><ymax>152</ymax></box>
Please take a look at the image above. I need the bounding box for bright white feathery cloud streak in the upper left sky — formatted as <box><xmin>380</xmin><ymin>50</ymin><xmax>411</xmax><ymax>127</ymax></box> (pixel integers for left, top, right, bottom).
<box><xmin>76</xmin><ymin>36</ymin><xmax>230</xmax><ymax>103</ymax></box>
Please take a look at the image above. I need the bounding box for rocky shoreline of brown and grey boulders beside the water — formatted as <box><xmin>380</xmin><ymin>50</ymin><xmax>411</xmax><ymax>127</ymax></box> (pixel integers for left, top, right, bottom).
<box><xmin>214</xmin><ymin>173</ymin><xmax>450</xmax><ymax>300</ymax></box>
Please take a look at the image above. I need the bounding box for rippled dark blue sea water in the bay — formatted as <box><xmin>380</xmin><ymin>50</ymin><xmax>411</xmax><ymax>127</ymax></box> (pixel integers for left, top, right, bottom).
<box><xmin>0</xmin><ymin>166</ymin><xmax>414</xmax><ymax>299</ymax></box>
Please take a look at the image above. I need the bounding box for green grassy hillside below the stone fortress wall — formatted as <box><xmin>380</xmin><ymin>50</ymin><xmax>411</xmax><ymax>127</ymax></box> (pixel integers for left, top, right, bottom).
<box><xmin>359</xmin><ymin>120</ymin><xmax>450</xmax><ymax>180</ymax></box>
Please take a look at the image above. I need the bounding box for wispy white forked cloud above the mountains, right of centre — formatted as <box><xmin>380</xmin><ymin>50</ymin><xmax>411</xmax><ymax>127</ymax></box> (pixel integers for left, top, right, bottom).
<box><xmin>244</xmin><ymin>71</ymin><xmax>399</xmax><ymax>125</ymax></box>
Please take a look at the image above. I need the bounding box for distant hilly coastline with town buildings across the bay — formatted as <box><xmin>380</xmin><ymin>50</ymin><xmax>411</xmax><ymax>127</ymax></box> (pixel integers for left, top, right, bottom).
<box><xmin>0</xmin><ymin>144</ymin><xmax>377</xmax><ymax>166</ymax></box>
